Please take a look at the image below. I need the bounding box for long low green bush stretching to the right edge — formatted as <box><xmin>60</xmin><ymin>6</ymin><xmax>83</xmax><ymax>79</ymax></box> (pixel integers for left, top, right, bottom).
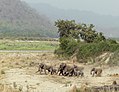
<box><xmin>77</xmin><ymin>42</ymin><xmax>119</xmax><ymax>60</ymax></box>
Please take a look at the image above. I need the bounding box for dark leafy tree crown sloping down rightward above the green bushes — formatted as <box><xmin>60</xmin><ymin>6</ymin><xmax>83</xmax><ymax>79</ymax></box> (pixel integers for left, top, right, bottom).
<box><xmin>55</xmin><ymin>20</ymin><xmax>105</xmax><ymax>43</ymax></box>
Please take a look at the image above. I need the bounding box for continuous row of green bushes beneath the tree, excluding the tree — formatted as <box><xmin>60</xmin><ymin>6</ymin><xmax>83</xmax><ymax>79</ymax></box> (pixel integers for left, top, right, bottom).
<box><xmin>55</xmin><ymin>37</ymin><xmax>119</xmax><ymax>63</ymax></box>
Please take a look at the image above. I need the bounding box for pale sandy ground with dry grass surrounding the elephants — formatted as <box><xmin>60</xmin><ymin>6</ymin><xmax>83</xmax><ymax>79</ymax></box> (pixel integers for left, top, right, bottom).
<box><xmin>0</xmin><ymin>53</ymin><xmax>119</xmax><ymax>92</ymax></box>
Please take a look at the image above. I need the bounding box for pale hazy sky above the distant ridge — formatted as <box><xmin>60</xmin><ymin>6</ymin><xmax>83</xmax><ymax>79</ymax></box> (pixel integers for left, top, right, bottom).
<box><xmin>23</xmin><ymin>0</ymin><xmax>119</xmax><ymax>16</ymax></box>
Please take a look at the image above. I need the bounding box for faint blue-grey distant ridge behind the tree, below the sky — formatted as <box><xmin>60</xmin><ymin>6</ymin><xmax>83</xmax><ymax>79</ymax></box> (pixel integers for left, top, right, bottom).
<box><xmin>30</xmin><ymin>3</ymin><xmax>119</xmax><ymax>37</ymax></box>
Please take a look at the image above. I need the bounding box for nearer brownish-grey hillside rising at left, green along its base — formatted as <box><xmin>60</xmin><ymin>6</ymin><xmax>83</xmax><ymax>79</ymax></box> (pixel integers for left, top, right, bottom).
<box><xmin>0</xmin><ymin>0</ymin><xmax>57</xmax><ymax>37</ymax></box>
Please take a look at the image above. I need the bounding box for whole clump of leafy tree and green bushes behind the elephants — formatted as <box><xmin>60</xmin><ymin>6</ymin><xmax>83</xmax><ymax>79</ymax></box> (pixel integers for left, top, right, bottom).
<box><xmin>55</xmin><ymin>20</ymin><xmax>119</xmax><ymax>62</ymax></box>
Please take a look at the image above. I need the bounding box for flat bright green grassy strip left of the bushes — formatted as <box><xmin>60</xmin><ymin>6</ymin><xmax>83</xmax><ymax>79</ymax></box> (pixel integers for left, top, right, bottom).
<box><xmin>0</xmin><ymin>40</ymin><xmax>58</xmax><ymax>50</ymax></box>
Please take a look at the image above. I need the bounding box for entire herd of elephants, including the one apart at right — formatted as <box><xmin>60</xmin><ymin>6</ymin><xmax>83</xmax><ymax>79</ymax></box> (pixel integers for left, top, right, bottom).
<box><xmin>36</xmin><ymin>63</ymin><xmax>102</xmax><ymax>77</ymax></box>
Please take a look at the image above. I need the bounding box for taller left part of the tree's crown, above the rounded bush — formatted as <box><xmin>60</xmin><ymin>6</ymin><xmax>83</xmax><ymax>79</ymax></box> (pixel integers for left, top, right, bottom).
<box><xmin>55</xmin><ymin>20</ymin><xmax>80</xmax><ymax>38</ymax></box>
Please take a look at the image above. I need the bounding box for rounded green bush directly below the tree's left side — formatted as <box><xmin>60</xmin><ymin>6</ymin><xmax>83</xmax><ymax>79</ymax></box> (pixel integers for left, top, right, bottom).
<box><xmin>55</xmin><ymin>37</ymin><xmax>78</xmax><ymax>57</ymax></box>
